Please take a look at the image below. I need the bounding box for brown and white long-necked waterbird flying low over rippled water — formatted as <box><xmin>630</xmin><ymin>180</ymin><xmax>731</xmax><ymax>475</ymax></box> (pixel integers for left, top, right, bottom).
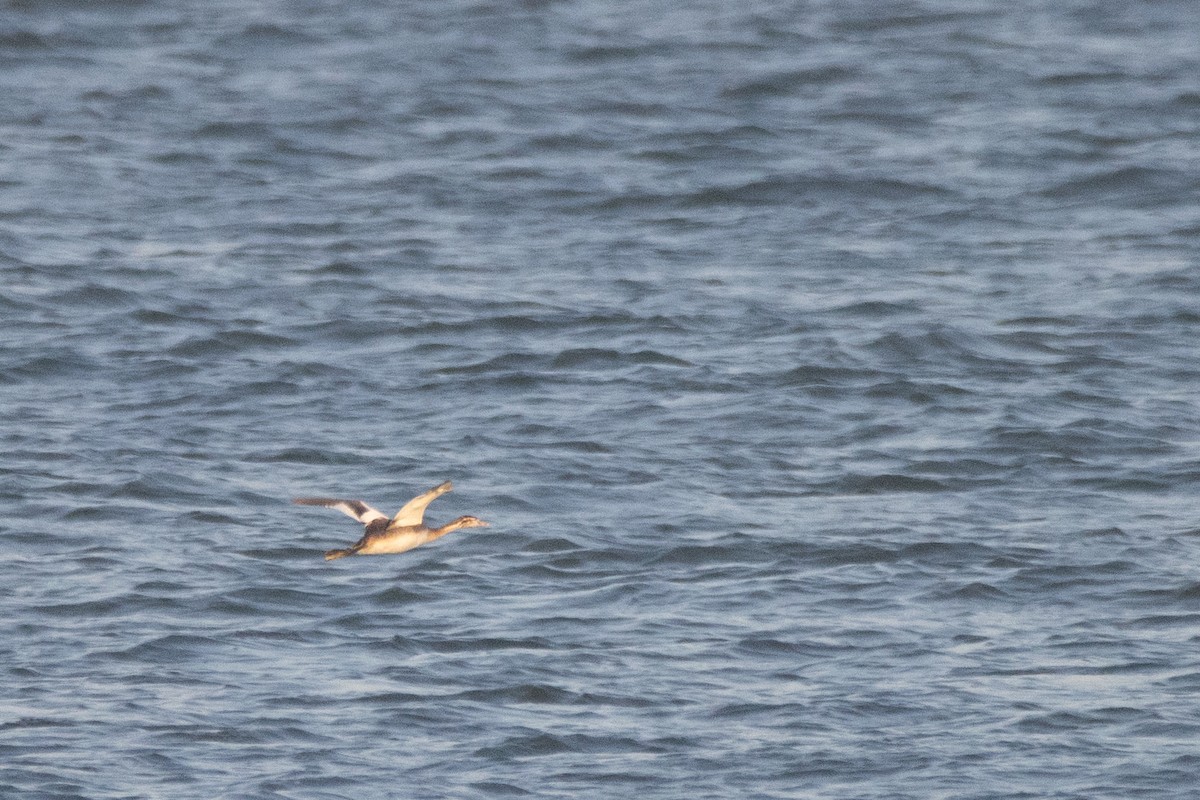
<box><xmin>293</xmin><ymin>481</ymin><xmax>487</xmax><ymax>561</ymax></box>
